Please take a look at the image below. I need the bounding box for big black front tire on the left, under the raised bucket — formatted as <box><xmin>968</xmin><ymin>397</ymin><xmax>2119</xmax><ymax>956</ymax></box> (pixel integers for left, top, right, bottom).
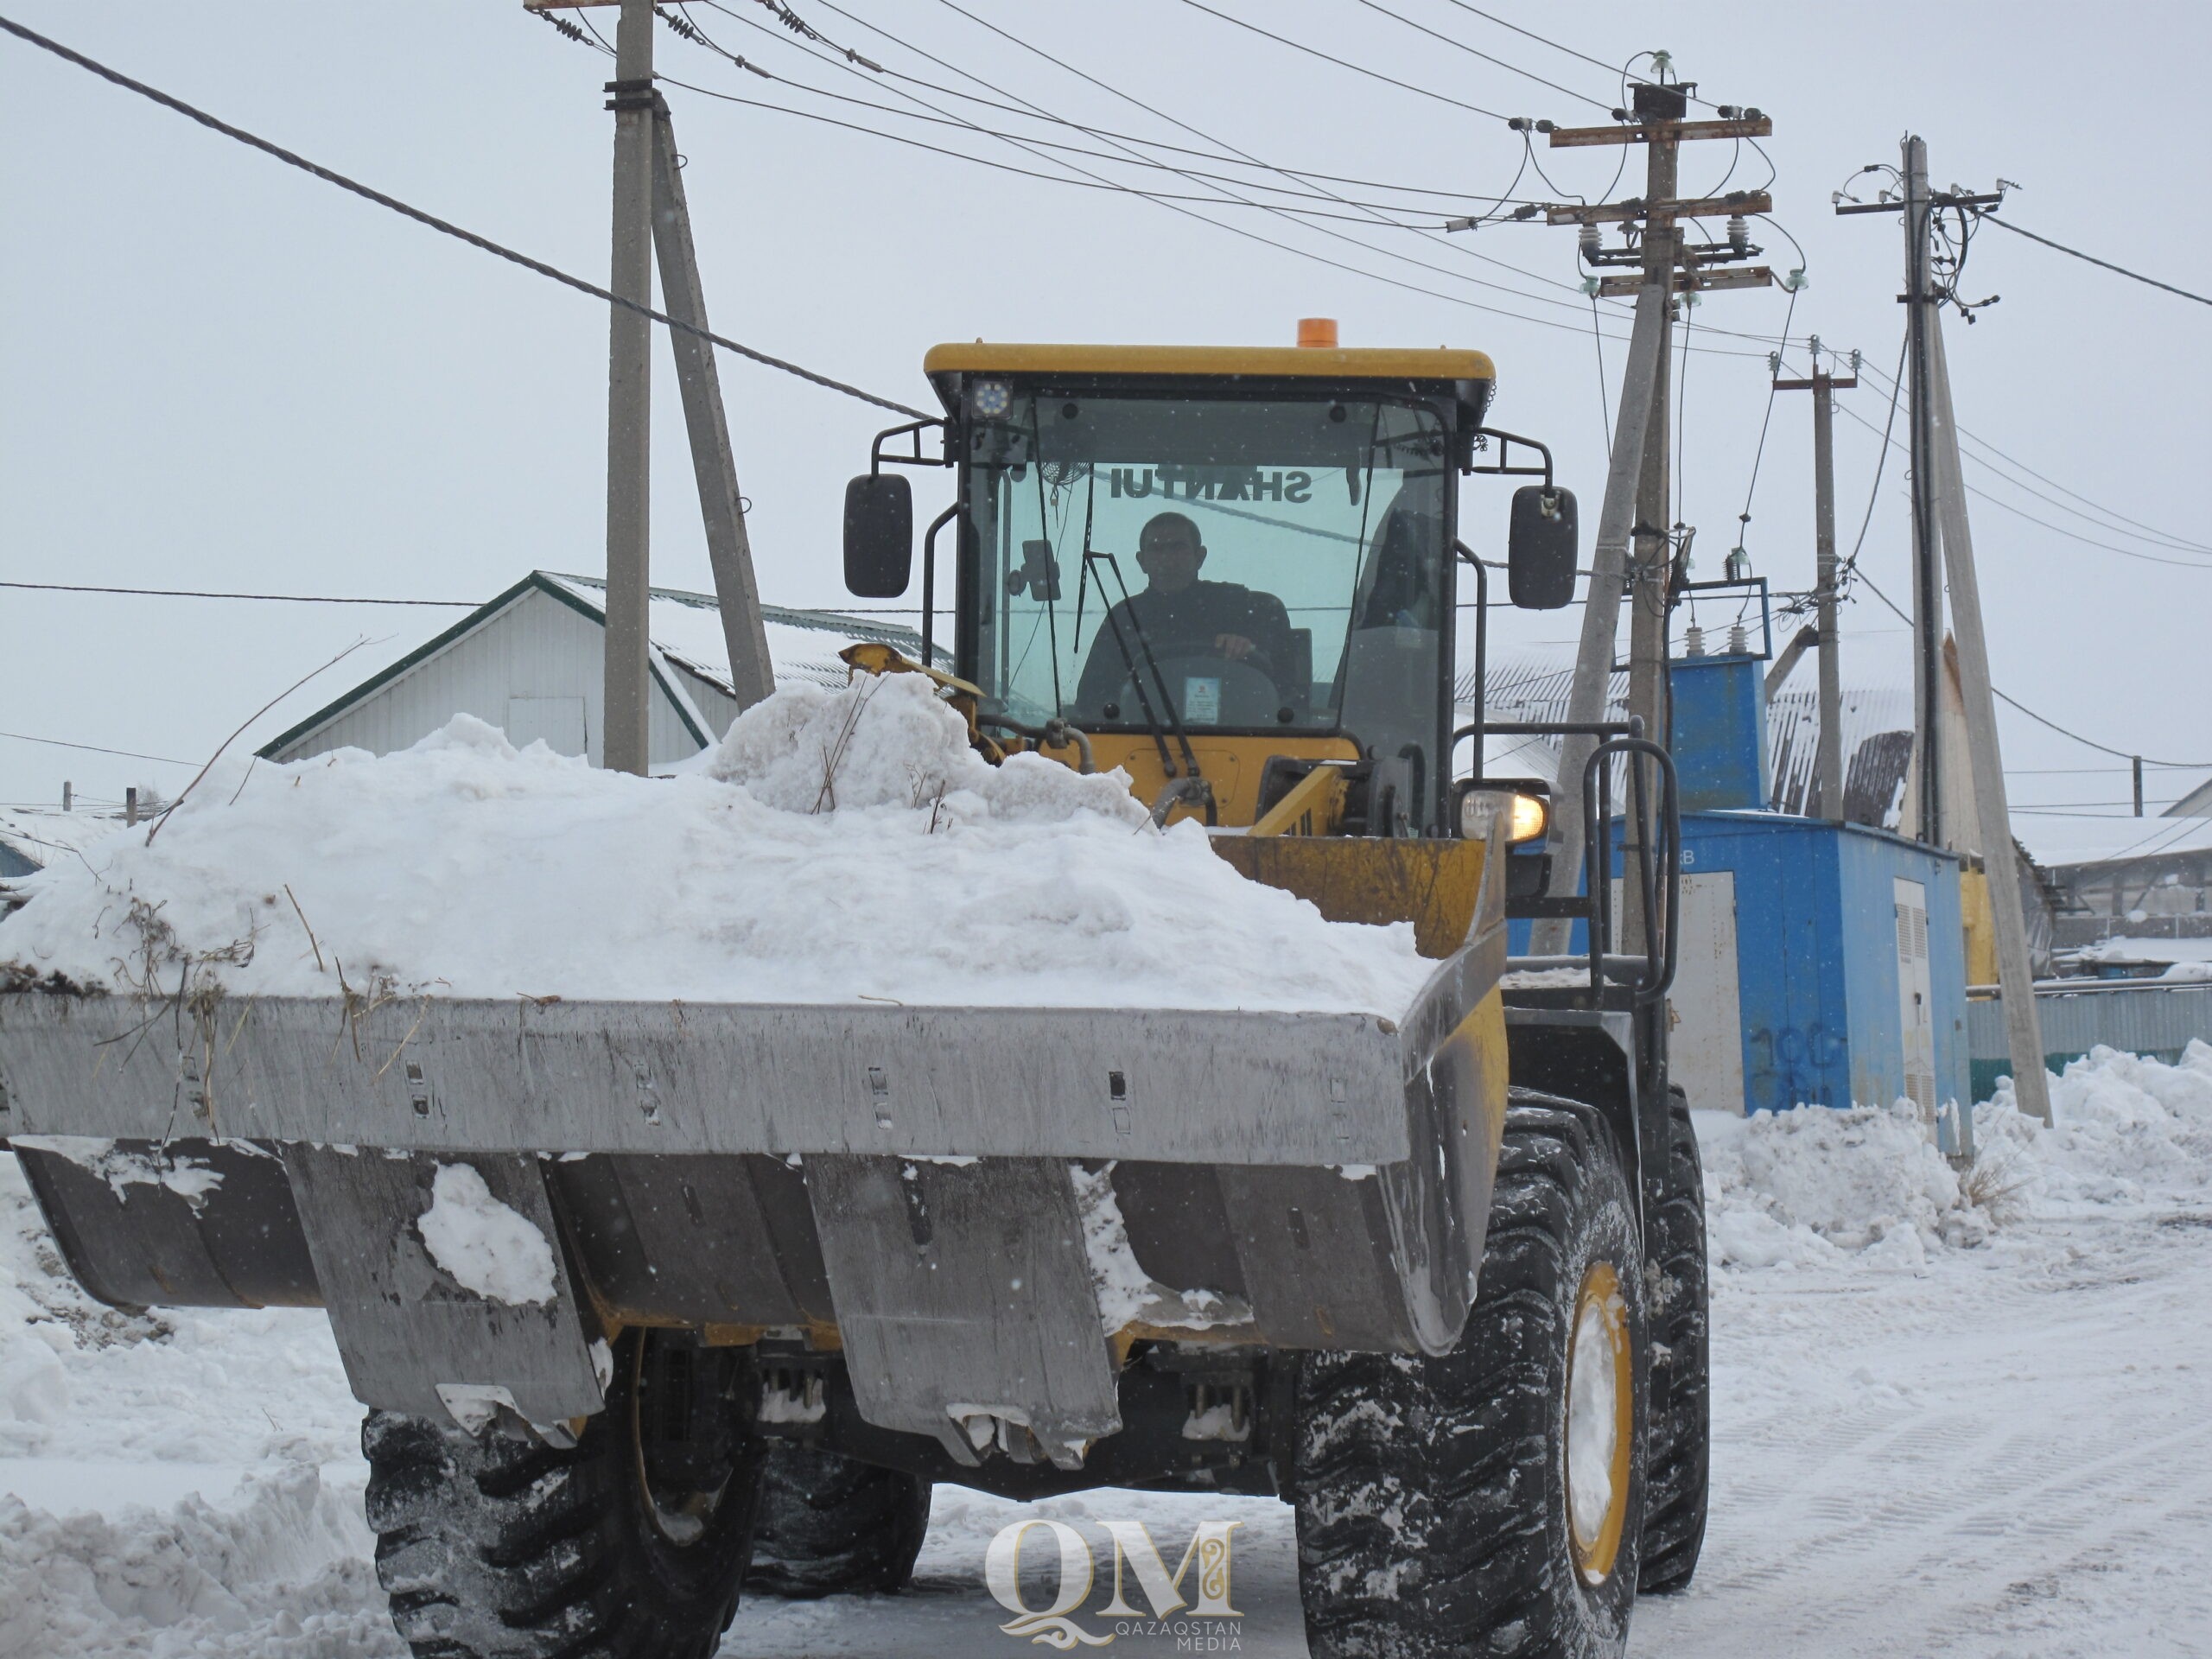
<box><xmin>360</xmin><ymin>1332</ymin><xmax>761</xmax><ymax>1659</ymax></box>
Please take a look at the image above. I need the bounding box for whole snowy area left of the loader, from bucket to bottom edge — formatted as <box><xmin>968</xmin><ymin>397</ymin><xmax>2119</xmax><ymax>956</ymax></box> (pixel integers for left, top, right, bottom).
<box><xmin>0</xmin><ymin>1154</ymin><xmax>404</xmax><ymax>1659</ymax></box>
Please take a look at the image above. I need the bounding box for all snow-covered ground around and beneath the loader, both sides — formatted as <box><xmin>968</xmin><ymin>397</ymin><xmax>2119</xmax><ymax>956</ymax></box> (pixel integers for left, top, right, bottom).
<box><xmin>0</xmin><ymin>1044</ymin><xmax>2212</xmax><ymax>1659</ymax></box>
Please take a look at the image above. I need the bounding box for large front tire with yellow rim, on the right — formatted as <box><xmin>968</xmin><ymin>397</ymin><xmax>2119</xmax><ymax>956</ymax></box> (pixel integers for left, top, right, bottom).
<box><xmin>1292</xmin><ymin>1090</ymin><xmax>1648</xmax><ymax>1659</ymax></box>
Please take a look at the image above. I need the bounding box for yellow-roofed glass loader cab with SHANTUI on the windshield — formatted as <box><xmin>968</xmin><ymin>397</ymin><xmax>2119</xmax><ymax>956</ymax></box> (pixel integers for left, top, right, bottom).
<box><xmin>847</xmin><ymin>343</ymin><xmax>1573</xmax><ymax>836</ymax></box>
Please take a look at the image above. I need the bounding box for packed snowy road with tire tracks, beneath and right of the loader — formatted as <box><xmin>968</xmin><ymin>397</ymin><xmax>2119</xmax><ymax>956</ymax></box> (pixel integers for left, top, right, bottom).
<box><xmin>723</xmin><ymin>1194</ymin><xmax>2212</xmax><ymax>1659</ymax></box>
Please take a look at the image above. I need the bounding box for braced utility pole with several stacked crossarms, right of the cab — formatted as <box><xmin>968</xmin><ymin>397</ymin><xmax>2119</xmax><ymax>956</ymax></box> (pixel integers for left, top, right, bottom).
<box><xmin>1531</xmin><ymin>84</ymin><xmax>1774</xmax><ymax>956</ymax></box>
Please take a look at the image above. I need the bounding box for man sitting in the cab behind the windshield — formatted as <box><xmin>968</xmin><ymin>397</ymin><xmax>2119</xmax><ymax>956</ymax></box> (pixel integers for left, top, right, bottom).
<box><xmin>1075</xmin><ymin>513</ymin><xmax>1294</xmax><ymax>719</ymax></box>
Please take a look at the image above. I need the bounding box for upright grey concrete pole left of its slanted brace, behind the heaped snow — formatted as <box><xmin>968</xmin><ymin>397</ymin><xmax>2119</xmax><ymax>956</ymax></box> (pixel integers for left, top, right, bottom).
<box><xmin>600</xmin><ymin>0</ymin><xmax>657</xmax><ymax>774</ymax></box>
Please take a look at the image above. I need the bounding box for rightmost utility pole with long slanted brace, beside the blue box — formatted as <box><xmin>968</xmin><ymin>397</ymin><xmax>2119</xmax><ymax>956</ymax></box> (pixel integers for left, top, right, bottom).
<box><xmin>1836</xmin><ymin>149</ymin><xmax>2050</xmax><ymax>1153</ymax></box>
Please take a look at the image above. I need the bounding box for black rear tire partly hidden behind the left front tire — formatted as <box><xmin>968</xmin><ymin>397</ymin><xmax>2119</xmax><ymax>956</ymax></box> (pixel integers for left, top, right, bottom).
<box><xmin>746</xmin><ymin>1440</ymin><xmax>929</xmax><ymax>1599</ymax></box>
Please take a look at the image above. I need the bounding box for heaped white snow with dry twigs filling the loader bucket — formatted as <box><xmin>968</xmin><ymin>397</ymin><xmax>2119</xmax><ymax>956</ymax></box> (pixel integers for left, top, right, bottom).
<box><xmin>0</xmin><ymin>675</ymin><xmax>1431</xmax><ymax>1015</ymax></box>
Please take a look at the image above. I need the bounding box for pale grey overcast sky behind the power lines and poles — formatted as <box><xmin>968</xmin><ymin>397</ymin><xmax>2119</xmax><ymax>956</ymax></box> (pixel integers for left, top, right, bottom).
<box><xmin>0</xmin><ymin>0</ymin><xmax>2212</xmax><ymax>841</ymax></box>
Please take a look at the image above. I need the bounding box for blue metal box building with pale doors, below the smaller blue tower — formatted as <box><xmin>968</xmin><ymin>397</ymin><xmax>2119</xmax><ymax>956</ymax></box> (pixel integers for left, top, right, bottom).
<box><xmin>1668</xmin><ymin>812</ymin><xmax>1971</xmax><ymax>1122</ymax></box>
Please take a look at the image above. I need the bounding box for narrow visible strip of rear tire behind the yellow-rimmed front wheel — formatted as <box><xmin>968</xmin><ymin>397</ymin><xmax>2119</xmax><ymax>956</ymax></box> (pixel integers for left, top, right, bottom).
<box><xmin>1637</xmin><ymin>1089</ymin><xmax>1712</xmax><ymax>1595</ymax></box>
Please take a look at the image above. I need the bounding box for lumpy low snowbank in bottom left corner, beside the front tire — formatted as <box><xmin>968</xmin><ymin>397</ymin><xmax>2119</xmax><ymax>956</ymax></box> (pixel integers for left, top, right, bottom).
<box><xmin>0</xmin><ymin>1462</ymin><xmax>403</xmax><ymax>1659</ymax></box>
